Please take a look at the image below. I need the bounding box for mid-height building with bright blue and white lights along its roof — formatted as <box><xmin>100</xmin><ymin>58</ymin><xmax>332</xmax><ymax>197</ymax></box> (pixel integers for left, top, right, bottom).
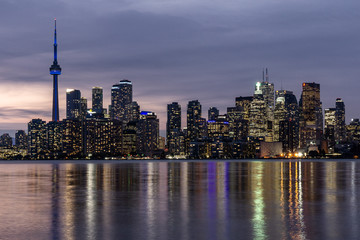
<box><xmin>137</xmin><ymin>111</ymin><xmax>159</xmax><ymax>157</ymax></box>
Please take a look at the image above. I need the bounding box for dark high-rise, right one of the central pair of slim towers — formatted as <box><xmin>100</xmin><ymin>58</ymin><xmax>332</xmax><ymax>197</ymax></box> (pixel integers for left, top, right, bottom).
<box><xmin>187</xmin><ymin>100</ymin><xmax>201</xmax><ymax>141</ymax></box>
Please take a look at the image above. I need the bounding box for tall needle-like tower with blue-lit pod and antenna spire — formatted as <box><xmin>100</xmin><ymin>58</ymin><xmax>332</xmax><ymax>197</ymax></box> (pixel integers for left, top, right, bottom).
<box><xmin>50</xmin><ymin>19</ymin><xmax>61</xmax><ymax>122</ymax></box>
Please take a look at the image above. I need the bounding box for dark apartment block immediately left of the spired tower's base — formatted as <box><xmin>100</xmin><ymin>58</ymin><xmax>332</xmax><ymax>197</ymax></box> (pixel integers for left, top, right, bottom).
<box><xmin>28</xmin><ymin>119</ymin><xmax>46</xmax><ymax>158</ymax></box>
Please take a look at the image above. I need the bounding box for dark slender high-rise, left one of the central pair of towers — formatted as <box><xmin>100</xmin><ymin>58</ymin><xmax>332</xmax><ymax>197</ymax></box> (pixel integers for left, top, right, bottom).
<box><xmin>166</xmin><ymin>102</ymin><xmax>181</xmax><ymax>154</ymax></box>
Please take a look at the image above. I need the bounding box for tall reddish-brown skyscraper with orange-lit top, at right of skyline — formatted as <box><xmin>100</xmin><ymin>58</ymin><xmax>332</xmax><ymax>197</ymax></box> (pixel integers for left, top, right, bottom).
<box><xmin>299</xmin><ymin>82</ymin><xmax>323</xmax><ymax>148</ymax></box>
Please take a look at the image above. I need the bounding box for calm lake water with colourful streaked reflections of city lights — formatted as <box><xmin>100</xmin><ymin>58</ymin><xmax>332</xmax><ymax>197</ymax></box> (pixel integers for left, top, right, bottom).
<box><xmin>0</xmin><ymin>160</ymin><xmax>360</xmax><ymax>240</ymax></box>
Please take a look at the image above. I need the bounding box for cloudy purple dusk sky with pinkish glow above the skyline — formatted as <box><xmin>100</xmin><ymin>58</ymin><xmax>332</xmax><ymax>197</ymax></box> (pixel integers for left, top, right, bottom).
<box><xmin>0</xmin><ymin>0</ymin><xmax>360</xmax><ymax>135</ymax></box>
